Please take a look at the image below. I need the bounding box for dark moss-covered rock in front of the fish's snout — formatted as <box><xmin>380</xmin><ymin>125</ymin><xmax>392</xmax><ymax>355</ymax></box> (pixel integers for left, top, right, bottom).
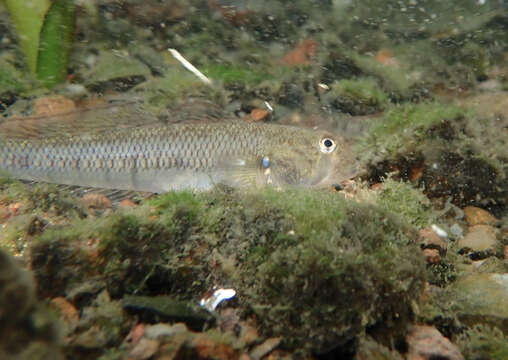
<box><xmin>358</xmin><ymin>103</ymin><xmax>508</xmax><ymax>214</ymax></box>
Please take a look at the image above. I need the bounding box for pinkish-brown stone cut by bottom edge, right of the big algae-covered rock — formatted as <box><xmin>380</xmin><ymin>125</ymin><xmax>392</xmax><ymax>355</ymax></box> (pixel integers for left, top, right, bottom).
<box><xmin>406</xmin><ymin>325</ymin><xmax>464</xmax><ymax>360</ymax></box>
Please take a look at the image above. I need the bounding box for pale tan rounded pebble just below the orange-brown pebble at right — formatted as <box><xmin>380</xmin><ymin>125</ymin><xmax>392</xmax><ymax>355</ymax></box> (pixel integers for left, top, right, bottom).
<box><xmin>458</xmin><ymin>225</ymin><xmax>497</xmax><ymax>259</ymax></box>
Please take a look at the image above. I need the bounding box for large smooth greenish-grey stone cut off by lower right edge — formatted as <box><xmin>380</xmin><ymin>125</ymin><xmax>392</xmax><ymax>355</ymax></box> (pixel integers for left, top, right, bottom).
<box><xmin>450</xmin><ymin>273</ymin><xmax>508</xmax><ymax>332</ymax></box>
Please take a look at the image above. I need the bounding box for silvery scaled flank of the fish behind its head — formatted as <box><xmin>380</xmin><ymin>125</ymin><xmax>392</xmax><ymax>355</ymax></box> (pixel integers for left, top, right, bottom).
<box><xmin>0</xmin><ymin>122</ymin><xmax>272</xmax><ymax>190</ymax></box>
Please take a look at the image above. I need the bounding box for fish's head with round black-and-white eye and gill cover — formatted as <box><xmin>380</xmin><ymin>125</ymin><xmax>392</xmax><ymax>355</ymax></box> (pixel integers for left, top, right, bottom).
<box><xmin>260</xmin><ymin>129</ymin><xmax>359</xmax><ymax>187</ymax></box>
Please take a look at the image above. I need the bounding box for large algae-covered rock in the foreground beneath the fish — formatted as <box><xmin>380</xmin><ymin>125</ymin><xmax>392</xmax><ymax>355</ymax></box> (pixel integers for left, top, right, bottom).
<box><xmin>25</xmin><ymin>188</ymin><xmax>425</xmax><ymax>352</ymax></box>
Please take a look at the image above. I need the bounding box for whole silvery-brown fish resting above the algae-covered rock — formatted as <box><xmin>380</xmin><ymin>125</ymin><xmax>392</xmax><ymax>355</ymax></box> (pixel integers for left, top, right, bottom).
<box><xmin>0</xmin><ymin>104</ymin><xmax>358</xmax><ymax>193</ymax></box>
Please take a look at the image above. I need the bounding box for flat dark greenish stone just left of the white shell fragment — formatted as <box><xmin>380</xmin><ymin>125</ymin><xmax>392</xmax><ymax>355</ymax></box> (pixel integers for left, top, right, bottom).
<box><xmin>122</xmin><ymin>296</ymin><xmax>214</xmax><ymax>330</ymax></box>
